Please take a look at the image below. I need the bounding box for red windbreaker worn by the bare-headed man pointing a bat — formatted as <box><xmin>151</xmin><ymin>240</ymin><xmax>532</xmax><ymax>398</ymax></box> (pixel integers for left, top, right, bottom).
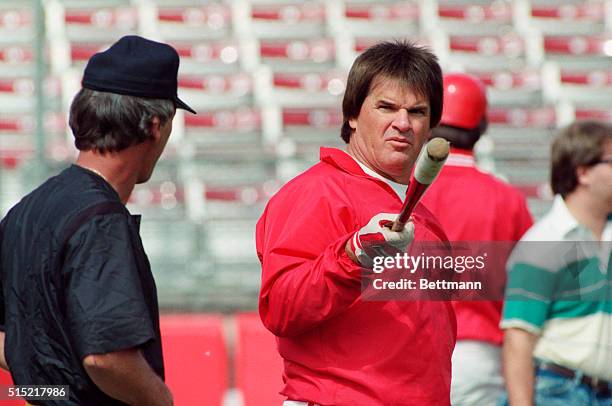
<box><xmin>257</xmin><ymin>148</ymin><xmax>456</xmax><ymax>406</ymax></box>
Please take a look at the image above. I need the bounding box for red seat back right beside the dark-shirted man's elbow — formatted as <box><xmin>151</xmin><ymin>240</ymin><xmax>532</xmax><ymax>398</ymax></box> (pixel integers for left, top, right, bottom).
<box><xmin>161</xmin><ymin>314</ymin><xmax>228</xmax><ymax>406</ymax></box>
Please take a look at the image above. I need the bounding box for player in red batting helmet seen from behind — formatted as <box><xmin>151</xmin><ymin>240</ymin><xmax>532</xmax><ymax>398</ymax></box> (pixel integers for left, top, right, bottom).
<box><xmin>423</xmin><ymin>73</ymin><xmax>533</xmax><ymax>406</ymax></box>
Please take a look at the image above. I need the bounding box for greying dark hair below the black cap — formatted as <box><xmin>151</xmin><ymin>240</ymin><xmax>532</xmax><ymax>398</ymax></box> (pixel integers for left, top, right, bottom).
<box><xmin>69</xmin><ymin>88</ymin><xmax>176</xmax><ymax>154</ymax></box>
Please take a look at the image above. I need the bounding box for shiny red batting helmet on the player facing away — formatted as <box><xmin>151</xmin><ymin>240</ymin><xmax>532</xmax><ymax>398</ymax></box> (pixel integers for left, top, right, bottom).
<box><xmin>440</xmin><ymin>73</ymin><xmax>487</xmax><ymax>130</ymax></box>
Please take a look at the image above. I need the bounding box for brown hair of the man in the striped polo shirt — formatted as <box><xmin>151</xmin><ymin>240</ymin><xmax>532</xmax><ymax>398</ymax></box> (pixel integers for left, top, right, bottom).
<box><xmin>550</xmin><ymin>120</ymin><xmax>612</xmax><ymax>197</ymax></box>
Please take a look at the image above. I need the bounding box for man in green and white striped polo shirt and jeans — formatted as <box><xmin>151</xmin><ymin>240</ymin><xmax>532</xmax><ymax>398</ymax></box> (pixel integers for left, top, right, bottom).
<box><xmin>501</xmin><ymin>121</ymin><xmax>612</xmax><ymax>406</ymax></box>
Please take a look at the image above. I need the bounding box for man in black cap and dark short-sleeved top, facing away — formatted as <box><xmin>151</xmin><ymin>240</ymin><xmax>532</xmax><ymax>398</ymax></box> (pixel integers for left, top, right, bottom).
<box><xmin>0</xmin><ymin>36</ymin><xmax>193</xmax><ymax>406</ymax></box>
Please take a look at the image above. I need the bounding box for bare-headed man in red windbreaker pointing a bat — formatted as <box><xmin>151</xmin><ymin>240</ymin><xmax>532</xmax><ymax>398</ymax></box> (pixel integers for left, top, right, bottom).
<box><xmin>257</xmin><ymin>42</ymin><xmax>456</xmax><ymax>406</ymax></box>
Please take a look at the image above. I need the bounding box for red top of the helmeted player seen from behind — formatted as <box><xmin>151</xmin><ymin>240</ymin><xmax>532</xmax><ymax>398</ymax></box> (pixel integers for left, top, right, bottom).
<box><xmin>422</xmin><ymin>148</ymin><xmax>533</xmax><ymax>345</ymax></box>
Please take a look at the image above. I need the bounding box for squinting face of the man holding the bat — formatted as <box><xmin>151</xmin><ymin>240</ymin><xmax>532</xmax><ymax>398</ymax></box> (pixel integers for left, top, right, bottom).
<box><xmin>348</xmin><ymin>77</ymin><xmax>431</xmax><ymax>184</ymax></box>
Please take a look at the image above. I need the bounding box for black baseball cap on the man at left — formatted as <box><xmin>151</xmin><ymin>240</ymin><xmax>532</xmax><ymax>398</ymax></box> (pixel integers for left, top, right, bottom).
<box><xmin>81</xmin><ymin>35</ymin><xmax>196</xmax><ymax>114</ymax></box>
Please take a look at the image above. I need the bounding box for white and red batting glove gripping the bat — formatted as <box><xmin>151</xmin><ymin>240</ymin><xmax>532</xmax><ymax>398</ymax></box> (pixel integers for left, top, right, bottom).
<box><xmin>350</xmin><ymin>213</ymin><xmax>414</xmax><ymax>268</ymax></box>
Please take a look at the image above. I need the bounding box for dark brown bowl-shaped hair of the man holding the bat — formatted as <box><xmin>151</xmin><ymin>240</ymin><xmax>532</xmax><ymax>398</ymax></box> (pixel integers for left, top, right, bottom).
<box><xmin>341</xmin><ymin>41</ymin><xmax>443</xmax><ymax>143</ymax></box>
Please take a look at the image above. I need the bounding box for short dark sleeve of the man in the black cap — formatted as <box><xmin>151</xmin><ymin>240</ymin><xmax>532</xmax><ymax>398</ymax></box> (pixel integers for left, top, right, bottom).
<box><xmin>63</xmin><ymin>214</ymin><xmax>155</xmax><ymax>359</ymax></box>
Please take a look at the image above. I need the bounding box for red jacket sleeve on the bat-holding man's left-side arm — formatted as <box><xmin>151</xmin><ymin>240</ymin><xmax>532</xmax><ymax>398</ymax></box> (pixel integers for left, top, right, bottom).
<box><xmin>257</xmin><ymin>182</ymin><xmax>361</xmax><ymax>336</ymax></box>
